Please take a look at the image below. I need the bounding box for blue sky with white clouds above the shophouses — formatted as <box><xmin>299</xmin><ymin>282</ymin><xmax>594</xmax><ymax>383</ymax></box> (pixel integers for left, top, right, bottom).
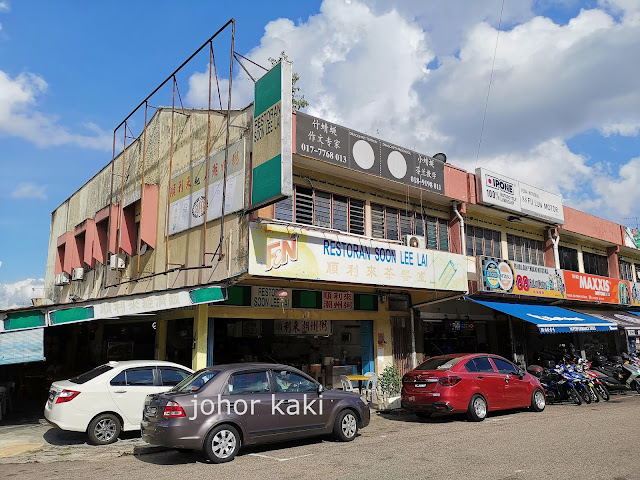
<box><xmin>0</xmin><ymin>0</ymin><xmax>640</xmax><ymax>307</ymax></box>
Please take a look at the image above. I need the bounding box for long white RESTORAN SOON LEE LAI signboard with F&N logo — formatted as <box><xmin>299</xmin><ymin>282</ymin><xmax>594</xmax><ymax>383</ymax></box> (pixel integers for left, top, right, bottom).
<box><xmin>249</xmin><ymin>223</ymin><xmax>467</xmax><ymax>292</ymax></box>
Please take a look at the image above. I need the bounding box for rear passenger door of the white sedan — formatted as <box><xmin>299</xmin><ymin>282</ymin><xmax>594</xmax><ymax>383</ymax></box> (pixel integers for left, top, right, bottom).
<box><xmin>108</xmin><ymin>366</ymin><xmax>160</xmax><ymax>430</ymax></box>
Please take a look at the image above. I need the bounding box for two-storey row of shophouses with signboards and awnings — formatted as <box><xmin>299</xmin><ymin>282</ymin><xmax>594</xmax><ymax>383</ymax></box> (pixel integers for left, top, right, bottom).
<box><xmin>0</xmin><ymin>96</ymin><xmax>640</xmax><ymax>391</ymax></box>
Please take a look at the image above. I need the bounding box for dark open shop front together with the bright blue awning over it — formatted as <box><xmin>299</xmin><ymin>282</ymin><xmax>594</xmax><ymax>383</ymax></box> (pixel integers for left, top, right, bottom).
<box><xmin>469</xmin><ymin>298</ymin><xmax>619</xmax><ymax>366</ymax></box>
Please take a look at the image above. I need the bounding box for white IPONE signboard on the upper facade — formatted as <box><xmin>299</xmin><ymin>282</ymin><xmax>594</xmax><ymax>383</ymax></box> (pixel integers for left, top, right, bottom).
<box><xmin>476</xmin><ymin>168</ymin><xmax>564</xmax><ymax>225</ymax></box>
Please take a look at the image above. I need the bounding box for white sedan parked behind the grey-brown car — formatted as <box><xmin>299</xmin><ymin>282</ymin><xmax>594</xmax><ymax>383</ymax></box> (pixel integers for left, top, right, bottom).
<box><xmin>44</xmin><ymin>360</ymin><xmax>193</xmax><ymax>445</ymax></box>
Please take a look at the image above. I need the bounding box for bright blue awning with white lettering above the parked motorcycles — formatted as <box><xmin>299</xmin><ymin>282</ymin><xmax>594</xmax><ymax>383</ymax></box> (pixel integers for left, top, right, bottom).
<box><xmin>467</xmin><ymin>297</ymin><xmax>618</xmax><ymax>333</ymax></box>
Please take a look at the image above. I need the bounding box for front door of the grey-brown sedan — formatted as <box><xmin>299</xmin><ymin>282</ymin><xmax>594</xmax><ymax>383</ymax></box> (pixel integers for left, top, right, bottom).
<box><xmin>271</xmin><ymin>369</ymin><xmax>332</xmax><ymax>433</ymax></box>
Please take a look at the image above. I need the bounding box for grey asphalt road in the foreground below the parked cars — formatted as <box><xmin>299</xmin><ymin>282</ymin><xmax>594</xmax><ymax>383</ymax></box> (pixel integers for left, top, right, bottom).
<box><xmin>0</xmin><ymin>394</ymin><xmax>640</xmax><ymax>480</ymax></box>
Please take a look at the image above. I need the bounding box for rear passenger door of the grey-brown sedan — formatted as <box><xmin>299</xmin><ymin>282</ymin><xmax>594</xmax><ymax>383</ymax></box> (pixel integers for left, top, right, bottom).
<box><xmin>222</xmin><ymin>369</ymin><xmax>279</xmax><ymax>438</ymax></box>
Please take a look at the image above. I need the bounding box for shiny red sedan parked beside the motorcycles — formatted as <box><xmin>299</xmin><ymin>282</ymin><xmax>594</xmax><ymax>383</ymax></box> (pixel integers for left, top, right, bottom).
<box><xmin>402</xmin><ymin>353</ymin><xmax>546</xmax><ymax>422</ymax></box>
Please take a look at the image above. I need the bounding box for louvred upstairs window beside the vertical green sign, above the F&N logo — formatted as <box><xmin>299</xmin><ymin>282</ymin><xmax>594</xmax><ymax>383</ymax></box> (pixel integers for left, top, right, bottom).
<box><xmin>275</xmin><ymin>185</ymin><xmax>364</xmax><ymax>235</ymax></box>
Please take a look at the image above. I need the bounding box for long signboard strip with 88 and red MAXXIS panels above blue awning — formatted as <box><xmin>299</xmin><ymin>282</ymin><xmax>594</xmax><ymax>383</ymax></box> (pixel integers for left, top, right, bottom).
<box><xmin>477</xmin><ymin>257</ymin><xmax>640</xmax><ymax>306</ymax></box>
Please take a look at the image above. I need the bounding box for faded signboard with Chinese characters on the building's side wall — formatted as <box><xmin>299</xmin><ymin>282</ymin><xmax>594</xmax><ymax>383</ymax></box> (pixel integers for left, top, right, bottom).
<box><xmin>169</xmin><ymin>139</ymin><xmax>245</xmax><ymax>235</ymax></box>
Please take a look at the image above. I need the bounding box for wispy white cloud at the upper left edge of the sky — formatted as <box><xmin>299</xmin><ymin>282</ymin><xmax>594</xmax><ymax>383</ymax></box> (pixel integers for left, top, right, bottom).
<box><xmin>0</xmin><ymin>70</ymin><xmax>112</xmax><ymax>150</ymax></box>
